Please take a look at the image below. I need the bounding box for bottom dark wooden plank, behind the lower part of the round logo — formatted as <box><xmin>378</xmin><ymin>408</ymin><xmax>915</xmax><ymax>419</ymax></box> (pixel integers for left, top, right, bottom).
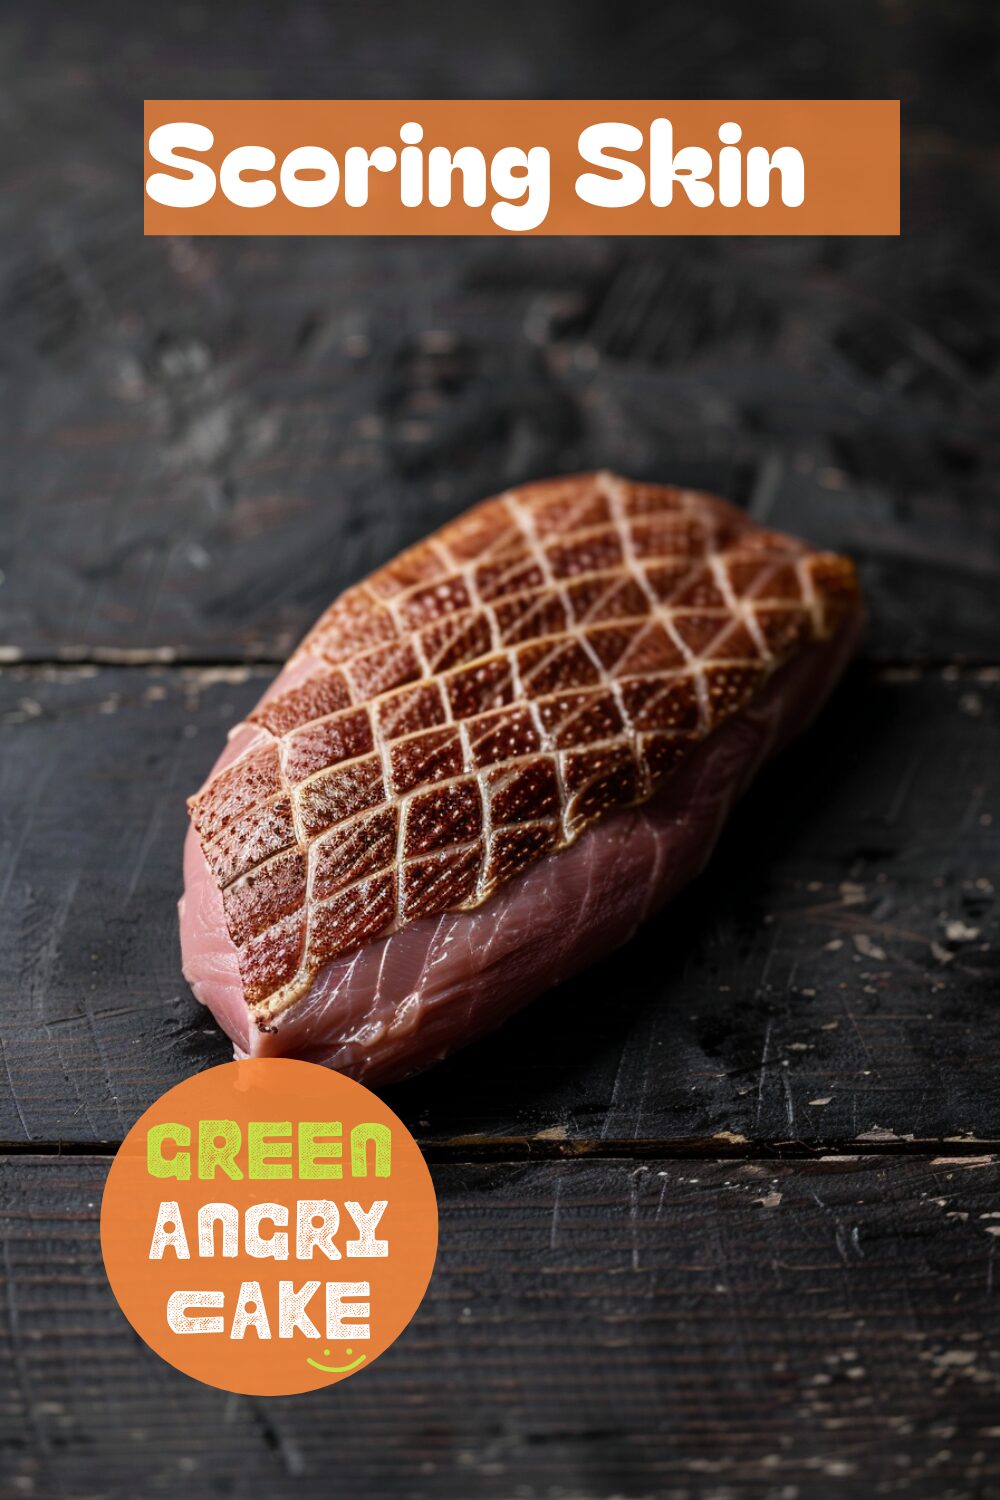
<box><xmin>0</xmin><ymin>1158</ymin><xmax>1000</xmax><ymax>1500</ymax></box>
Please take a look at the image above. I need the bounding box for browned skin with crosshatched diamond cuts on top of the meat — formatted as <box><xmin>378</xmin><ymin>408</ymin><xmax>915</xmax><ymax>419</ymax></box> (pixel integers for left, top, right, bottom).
<box><xmin>190</xmin><ymin>474</ymin><xmax>858</xmax><ymax>1019</ymax></box>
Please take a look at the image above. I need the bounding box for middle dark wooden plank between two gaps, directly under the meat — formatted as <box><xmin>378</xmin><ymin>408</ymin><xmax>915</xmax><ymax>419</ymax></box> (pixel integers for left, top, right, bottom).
<box><xmin>0</xmin><ymin>666</ymin><xmax>1000</xmax><ymax>1154</ymax></box>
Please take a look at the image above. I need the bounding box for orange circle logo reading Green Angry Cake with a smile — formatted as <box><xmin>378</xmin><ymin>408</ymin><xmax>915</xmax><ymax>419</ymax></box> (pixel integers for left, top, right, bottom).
<box><xmin>100</xmin><ymin>1058</ymin><xmax>438</xmax><ymax>1397</ymax></box>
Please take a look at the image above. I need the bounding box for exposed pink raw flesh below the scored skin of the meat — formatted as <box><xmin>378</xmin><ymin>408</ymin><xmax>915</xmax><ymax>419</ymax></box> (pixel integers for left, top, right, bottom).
<box><xmin>180</xmin><ymin>617</ymin><xmax>859</xmax><ymax>1082</ymax></box>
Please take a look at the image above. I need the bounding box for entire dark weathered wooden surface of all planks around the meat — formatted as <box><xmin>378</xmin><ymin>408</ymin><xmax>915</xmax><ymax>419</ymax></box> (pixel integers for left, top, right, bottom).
<box><xmin>0</xmin><ymin>0</ymin><xmax>1000</xmax><ymax>1500</ymax></box>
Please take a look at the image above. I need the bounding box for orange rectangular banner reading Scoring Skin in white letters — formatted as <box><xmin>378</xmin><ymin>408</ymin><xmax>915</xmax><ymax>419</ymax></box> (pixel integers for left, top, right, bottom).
<box><xmin>144</xmin><ymin>99</ymin><xmax>900</xmax><ymax>236</ymax></box>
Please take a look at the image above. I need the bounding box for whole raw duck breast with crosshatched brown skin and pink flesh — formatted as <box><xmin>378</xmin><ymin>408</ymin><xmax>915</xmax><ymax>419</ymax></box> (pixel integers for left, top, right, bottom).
<box><xmin>180</xmin><ymin>474</ymin><xmax>861</xmax><ymax>1082</ymax></box>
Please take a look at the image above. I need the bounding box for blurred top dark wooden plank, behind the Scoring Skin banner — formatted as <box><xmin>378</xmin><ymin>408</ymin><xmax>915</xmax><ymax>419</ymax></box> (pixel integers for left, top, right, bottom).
<box><xmin>0</xmin><ymin>0</ymin><xmax>1000</xmax><ymax>662</ymax></box>
